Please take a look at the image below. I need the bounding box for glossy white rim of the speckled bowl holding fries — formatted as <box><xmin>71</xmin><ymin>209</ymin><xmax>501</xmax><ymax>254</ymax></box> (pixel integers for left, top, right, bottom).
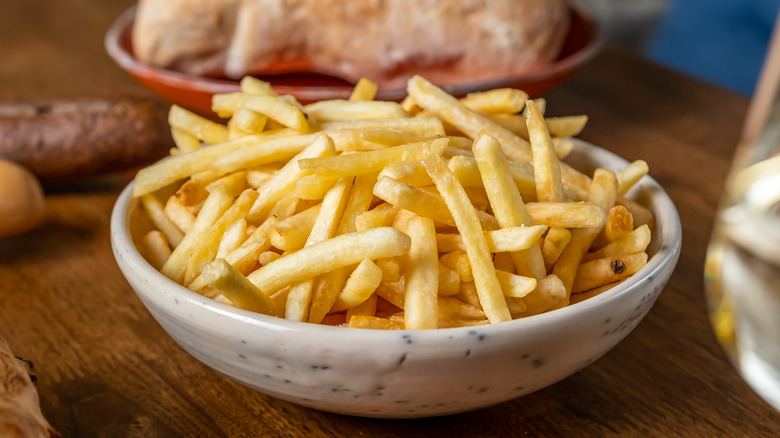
<box><xmin>111</xmin><ymin>139</ymin><xmax>682</xmax><ymax>341</ymax></box>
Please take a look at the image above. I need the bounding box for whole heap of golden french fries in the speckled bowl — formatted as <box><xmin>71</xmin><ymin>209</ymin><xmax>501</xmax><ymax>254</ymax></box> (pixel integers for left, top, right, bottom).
<box><xmin>134</xmin><ymin>76</ymin><xmax>653</xmax><ymax>329</ymax></box>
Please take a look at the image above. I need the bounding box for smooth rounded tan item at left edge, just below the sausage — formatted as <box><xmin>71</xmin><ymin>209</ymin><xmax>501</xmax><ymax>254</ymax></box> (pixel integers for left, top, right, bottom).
<box><xmin>0</xmin><ymin>160</ymin><xmax>44</xmax><ymax>237</ymax></box>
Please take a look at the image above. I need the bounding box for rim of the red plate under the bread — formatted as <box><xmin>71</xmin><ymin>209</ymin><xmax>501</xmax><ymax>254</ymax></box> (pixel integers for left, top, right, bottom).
<box><xmin>103</xmin><ymin>5</ymin><xmax>606</xmax><ymax>100</ymax></box>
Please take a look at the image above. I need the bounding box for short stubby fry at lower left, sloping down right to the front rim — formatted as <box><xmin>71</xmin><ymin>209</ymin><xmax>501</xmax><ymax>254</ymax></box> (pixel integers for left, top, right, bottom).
<box><xmin>203</xmin><ymin>259</ymin><xmax>278</xmax><ymax>316</ymax></box>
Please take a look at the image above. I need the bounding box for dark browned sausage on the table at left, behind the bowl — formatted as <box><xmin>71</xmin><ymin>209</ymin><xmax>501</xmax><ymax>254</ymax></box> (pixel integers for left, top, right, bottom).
<box><xmin>0</xmin><ymin>96</ymin><xmax>173</xmax><ymax>182</ymax></box>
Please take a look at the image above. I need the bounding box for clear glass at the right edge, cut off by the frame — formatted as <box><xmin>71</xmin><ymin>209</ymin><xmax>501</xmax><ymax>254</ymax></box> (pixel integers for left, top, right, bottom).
<box><xmin>704</xmin><ymin>14</ymin><xmax>780</xmax><ymax>410</ymax></box>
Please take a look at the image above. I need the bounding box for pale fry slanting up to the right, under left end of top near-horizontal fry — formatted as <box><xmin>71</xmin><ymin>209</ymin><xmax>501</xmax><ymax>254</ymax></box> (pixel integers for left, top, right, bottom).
<box><xmin>247</xmin><ymin>135</ymin><xmax>336</xmax><ymax>223</ymax></box>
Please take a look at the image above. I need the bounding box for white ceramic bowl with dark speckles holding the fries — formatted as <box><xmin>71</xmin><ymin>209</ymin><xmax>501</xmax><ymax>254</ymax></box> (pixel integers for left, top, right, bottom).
<box><xmin>111</xmin><ymin>141</ymin><xmax>681</xmax><ymax>418</ymax></box>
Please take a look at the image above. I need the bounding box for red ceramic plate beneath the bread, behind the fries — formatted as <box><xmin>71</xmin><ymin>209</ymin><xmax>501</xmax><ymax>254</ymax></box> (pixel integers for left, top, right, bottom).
<box><xmin>105</xmin><ymin>7</ymin><xmax>604</xmax><ymax>117</ymax></box>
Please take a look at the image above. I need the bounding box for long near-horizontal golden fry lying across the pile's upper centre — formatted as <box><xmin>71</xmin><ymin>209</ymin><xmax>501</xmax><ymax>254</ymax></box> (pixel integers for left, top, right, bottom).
<box><xmin>300</xmin><ymin>138</ymin><xmax>447</xmax><ymax>178</ymax></box>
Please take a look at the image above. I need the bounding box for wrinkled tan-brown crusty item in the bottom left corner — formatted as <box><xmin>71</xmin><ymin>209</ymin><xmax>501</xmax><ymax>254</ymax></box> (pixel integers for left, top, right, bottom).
<box><xmin>0</xmin><ymin>338</ymin><xmax>60</xmax><ymax>438</ymax></box>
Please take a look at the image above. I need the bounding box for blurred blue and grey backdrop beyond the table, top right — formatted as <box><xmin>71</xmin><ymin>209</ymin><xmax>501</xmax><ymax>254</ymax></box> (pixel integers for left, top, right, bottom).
<box><xmin>573</xmin><ymin>0</ymin><xmax>780</xmax><ymax>96</ymax></box>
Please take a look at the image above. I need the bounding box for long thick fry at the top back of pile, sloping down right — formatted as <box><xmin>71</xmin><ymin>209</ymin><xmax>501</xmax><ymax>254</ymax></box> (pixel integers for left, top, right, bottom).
<box><xmin>407</xmin><ymin>76</ymin><xmax>532</xmax><ymax>162</ymax></box>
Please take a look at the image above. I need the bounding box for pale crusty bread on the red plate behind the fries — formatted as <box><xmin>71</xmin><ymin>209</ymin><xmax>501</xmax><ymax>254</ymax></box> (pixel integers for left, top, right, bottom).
<box><xmin>133</xmin><ymin>0</ymin><xmax>570</xmax><ymax>87</ymax></box>
